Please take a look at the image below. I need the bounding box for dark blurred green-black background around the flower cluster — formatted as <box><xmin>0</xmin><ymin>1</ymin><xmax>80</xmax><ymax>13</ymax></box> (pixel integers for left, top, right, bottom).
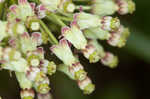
<box><xmin>0</xmin><ymin>0</ymin><xmax>150</xmax><ymax>99</ymax></box>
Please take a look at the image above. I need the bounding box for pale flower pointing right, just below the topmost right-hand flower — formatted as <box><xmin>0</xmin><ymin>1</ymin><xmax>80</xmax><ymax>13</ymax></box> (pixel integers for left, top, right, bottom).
<box><xmin>74</xmin><ymin>12</ymin><xmax>120</xmax><ymax>31</ymax></box>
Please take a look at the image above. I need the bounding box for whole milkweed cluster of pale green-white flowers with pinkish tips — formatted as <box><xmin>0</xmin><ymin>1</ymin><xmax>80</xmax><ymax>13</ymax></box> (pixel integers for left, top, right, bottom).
<box><xmin>0</xmin><ymin>0</ymin><xmax>135</xmax><ymax>99</ymax></box>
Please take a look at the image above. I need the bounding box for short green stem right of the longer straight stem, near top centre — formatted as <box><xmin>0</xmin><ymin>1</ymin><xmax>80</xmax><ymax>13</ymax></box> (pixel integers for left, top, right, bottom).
<box><xmin>47</xmin><ymin>13</ymin><xmax>66</xmax><ymax>27</ymax></box>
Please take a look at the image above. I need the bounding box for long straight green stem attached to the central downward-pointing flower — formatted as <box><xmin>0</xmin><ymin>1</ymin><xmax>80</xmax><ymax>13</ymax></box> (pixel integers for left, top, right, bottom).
<box><xmin>39</xmin><ymin>20</ymin><xmax>58</xmax><ymax>44</ymax></box>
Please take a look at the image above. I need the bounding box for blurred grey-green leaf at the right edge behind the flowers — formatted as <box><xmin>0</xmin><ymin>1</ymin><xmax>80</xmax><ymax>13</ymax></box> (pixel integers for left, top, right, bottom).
<box><xmin>125</xmin><ymin>27</ymin><xmax>150</xmax><ymax>63</ymax></box>
